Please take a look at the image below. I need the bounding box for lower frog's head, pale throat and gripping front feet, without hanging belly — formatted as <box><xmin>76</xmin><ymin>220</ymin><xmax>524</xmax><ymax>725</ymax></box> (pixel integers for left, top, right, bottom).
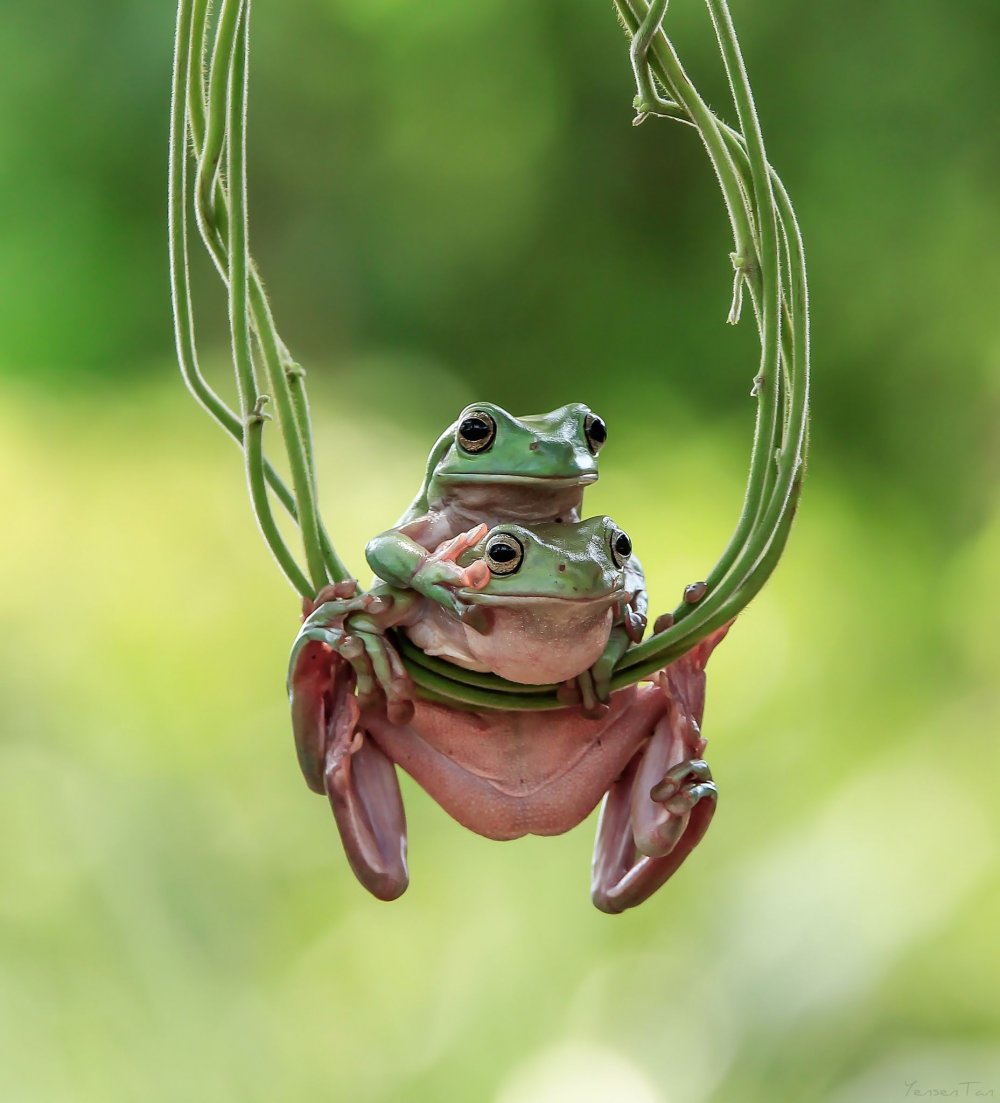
<box><xmin>299</xmin><ymin>517</ymin><xmax>645</xmax><ymax>719</ymax></box>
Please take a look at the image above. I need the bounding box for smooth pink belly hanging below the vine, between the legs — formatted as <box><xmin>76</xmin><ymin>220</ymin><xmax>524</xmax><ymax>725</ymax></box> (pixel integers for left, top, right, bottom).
<box><xmin>363</xmin><ymin>686</ymin><xmax>663</xmax><ymax>839</ymax></box>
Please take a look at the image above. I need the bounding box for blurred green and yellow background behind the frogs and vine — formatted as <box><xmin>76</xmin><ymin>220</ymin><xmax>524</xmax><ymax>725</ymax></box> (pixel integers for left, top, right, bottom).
<box><xmin>0</xmin><ymin>0</ymin><xmax>1000</xmax><ymax>1103</ymax></box>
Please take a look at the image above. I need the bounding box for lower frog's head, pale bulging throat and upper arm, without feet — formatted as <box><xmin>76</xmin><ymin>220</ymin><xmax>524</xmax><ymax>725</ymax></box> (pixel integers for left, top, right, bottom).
<box><xmin>399</xmin><ymin>517</ymin><xmax>632</xmax><ymax>685</ymax></box>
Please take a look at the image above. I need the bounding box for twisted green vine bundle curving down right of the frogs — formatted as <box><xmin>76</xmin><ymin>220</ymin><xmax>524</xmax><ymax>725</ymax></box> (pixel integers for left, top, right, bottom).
<box><xmin>399</xmin><ymin>0</ymin><xmax>808</xmax><ymax>707</ymax></box>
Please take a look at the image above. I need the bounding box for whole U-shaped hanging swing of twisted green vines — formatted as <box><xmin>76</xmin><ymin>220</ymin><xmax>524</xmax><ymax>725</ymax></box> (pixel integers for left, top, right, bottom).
<box><xmin>170</xmin><ymin>0</ymin><xmax>809</xmax><ymax>709</ymax></box>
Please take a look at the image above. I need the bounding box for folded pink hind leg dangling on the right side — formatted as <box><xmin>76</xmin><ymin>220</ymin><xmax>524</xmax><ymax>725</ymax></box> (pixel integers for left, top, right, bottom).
<box><xmin>592</xmin><ymin>625</ymin><xmax>728</xmax><ymax>913</ymax></box>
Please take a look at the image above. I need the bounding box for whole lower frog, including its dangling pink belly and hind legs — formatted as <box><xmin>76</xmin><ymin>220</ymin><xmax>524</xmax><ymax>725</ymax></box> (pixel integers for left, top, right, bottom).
<box><xmin>289</xmin><ymin>517</ymin><xmax>724</xmax><ymax>912</ymax></box>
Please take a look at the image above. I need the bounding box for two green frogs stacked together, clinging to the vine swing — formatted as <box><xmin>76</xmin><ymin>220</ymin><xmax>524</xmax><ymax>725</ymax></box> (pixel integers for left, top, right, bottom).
<box><xmin>289</xmin><ymin>403</ymin><xmax>724</xmax><ymax>912</ymax></box>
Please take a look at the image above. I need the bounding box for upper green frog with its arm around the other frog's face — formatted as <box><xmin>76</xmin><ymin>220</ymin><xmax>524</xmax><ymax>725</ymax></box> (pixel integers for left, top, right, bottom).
<box><xmin>366</xmin><ymin>403</ymin><xmax>607</xmax><ymax>615</ymax></box>
